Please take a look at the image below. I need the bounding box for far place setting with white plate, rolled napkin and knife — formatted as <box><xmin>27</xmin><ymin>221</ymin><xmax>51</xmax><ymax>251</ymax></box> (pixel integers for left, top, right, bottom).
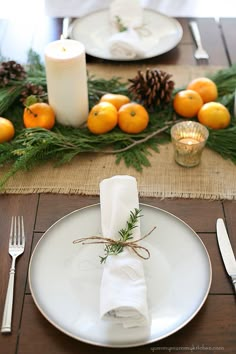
<box><xmin>63</xmin><ymin>0</ymin><xmax>183</xmax><ymax>61</ymax></box>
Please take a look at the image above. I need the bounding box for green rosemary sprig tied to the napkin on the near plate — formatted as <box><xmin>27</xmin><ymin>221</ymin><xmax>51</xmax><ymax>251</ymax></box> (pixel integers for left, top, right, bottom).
<box><xmin>100</xmin><ymin>208</ymin><xmax>142</xmax><ymax>263</ymax></box>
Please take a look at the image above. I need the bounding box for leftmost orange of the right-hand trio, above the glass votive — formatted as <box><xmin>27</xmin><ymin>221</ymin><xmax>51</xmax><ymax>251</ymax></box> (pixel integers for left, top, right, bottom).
<box><xmin>173</xmin><ymin>90</ymin><xmax>203</xmax><ymax>118</ymax></box>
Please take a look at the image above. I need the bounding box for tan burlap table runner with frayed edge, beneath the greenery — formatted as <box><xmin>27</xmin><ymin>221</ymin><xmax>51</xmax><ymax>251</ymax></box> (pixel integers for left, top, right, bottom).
<box><xmin>0</xmin><ymin>63</ymin><xmax>236</xmax><ymax>199</ymax></box>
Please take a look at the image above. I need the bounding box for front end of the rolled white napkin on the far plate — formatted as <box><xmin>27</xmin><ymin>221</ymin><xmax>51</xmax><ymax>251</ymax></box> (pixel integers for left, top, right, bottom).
<box><xmin>108</xmin><ymin>28</ymin><xmax>145</xmax><ymax>59</ymax></box>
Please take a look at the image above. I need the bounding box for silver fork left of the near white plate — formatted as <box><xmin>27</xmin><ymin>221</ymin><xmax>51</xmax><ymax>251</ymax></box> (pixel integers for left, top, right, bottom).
<box><xmin>1</xmin><ymin>216</ymin><xmax>25</xmax><ymax>333</ymax></box>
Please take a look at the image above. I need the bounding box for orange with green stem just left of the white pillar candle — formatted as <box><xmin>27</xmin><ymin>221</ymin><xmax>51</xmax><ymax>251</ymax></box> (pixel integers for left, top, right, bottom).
<box><xmin>23</xmin><ymin>102</ymin><xmax>55</xmax><ymax>129</ymax></box>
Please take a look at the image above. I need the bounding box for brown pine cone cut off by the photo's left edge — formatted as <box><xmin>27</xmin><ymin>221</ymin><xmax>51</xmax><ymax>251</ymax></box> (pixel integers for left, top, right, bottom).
<box><xmin>0</xmin><ymin>60</ymin><xmax>26</xmax><ymax>87</ymax></box>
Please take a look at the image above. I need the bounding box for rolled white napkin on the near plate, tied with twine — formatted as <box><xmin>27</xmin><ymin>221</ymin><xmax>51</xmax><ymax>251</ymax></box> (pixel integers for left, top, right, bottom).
<box><xmin>100</xmin><ymin>176</ymin><xmax>149</xmax><ymax>328</ymax></box>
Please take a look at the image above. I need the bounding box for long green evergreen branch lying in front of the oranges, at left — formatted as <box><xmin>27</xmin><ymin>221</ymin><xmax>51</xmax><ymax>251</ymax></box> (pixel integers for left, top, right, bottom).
<box><xmin>0</xmin><ymin>120</ymin><xmax>171</xmax><ymax>188</ymax></box>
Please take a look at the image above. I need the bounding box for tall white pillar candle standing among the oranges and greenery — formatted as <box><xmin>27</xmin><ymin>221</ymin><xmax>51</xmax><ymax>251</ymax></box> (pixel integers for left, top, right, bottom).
<box><xmin>45</xmin><ymin>39</ymin><xmax>88</xmax><ymax>127</ymax></box>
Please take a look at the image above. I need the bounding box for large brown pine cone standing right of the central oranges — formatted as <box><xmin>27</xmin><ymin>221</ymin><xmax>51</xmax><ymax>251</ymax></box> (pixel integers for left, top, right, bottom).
<box><xmin>128</xmin><ymin>69</ymin><xmax>175</xmax><ymax>109</ymax></box>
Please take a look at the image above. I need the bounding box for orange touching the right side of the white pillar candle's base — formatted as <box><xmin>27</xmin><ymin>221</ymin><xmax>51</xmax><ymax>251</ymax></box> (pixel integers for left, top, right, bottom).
<box><xmin>87</xmin><ymin>102</ymin><xmax>118</xmax><ymax>134</ymax></box>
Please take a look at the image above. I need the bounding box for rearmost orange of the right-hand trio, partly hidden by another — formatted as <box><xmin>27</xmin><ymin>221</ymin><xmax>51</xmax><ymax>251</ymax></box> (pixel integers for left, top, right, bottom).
<box><xmin>187</xmin><ymin>77</ymin><xmax>218</xmax><ymax>103</ymax></box>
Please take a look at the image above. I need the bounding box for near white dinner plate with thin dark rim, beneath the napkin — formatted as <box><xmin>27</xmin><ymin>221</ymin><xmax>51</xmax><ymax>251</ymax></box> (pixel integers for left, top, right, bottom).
<box><xmin>29</xmin><ymin>204</ymin><xmax>212</xmax><ymax>347</ymax></box>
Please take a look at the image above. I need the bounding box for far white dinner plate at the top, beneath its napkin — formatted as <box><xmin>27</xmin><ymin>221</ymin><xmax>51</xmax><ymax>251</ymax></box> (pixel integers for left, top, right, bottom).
<box><xmin>69</xmin><ymin>9</ymin><xmax>183</xmax><ymax>61</ymax></box>
